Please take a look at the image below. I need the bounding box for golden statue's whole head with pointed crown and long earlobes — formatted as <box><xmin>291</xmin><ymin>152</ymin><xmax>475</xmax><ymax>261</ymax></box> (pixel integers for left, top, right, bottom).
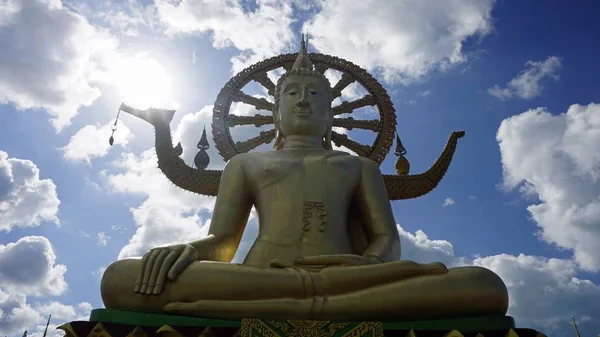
<box><xmin>273</xmin><ymin>37</ymin><xmax>333</xmax><ymax>149</ymax></box>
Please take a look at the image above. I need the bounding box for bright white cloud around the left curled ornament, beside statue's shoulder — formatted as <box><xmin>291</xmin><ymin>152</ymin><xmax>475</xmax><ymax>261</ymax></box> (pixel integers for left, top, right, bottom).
<box><xmin>104</xmin><ymin>106</ymin><xmax>224</xmax><ymax>258</ymax></box>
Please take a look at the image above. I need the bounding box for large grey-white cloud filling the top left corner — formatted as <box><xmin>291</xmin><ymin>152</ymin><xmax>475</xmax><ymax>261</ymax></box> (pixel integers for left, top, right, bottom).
<box><xmin>0</xmin><ymin>0</ymin><xmax>117</xmax><ymax>131</ymax></box>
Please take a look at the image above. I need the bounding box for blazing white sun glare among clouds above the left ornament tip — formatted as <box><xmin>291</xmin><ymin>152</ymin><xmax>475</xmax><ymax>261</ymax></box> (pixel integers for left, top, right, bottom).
<box><xmin>105</xmin><ymin>57</ymin><xmax>174</xmax><ymax>109</ymax></box>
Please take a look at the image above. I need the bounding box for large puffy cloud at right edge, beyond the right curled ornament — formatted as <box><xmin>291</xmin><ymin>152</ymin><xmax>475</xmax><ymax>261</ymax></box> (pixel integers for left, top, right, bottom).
<box><xmin>496</xmin><ymin>104</ymin><xmax>600</xmax><ymax>272</ymax></box>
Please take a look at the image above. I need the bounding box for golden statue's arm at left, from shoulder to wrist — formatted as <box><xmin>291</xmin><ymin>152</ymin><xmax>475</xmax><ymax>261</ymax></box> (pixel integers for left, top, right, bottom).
<box><xmin>191</xmin><ymin>155</ymin><xmax>252</xmax><ymax>262</ymax></box>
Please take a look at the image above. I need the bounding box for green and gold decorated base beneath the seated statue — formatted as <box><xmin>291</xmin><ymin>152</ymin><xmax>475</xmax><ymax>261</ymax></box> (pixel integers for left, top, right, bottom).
<box><xmin>58</xmin><ymin>309</ymin><xmax>545</xmax><ymax>337</ymax></box>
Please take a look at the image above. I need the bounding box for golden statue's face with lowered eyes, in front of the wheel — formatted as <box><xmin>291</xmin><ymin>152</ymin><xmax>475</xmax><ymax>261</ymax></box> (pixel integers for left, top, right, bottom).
<box><xmin>277</xmin><ymin>75</ymin><xmax>332</xmax><ymax>137</ymax></box>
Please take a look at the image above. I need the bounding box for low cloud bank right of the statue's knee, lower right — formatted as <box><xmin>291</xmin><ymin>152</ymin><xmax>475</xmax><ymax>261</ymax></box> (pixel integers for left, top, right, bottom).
<box><xmin>398</xmin><ymin>226</ymin><xmax>600</xmax><ymax>336</ymax></box>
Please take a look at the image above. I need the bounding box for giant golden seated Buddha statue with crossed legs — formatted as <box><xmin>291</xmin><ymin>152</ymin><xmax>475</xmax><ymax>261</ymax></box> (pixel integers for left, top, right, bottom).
<box><xmin>101</xmin><ymin>36</ymin><xmax>508</xmax><ymax>321</ymax></box>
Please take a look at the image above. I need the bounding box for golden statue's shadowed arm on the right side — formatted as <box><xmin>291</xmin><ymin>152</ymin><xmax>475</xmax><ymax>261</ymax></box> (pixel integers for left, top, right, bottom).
<box><xmin>356</xmin><ymin>157</ymin><xmax>400</xmax><ymax>262</ymax></box>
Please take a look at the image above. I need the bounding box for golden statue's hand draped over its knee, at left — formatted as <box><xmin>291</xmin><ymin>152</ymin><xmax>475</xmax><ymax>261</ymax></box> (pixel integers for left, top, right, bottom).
<box><xmin>133</xmin><ymin>244</ymin><xmax>198</xmax><ymax>295</ymax></box>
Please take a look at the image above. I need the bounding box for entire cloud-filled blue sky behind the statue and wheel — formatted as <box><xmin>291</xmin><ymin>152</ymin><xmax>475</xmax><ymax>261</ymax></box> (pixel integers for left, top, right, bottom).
<box><xmin>0</xmin><ymin>0</ymin><xmax>600</xmax><ymax>336</ymax></box>
